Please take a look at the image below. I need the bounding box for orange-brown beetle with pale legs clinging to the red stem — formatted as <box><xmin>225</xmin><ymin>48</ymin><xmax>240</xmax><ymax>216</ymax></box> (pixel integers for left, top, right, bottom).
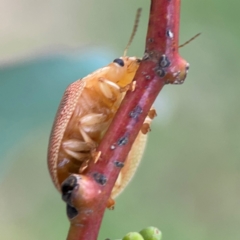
<box><xmin>48</xmin><ymin>9</ymin><xmax>155</xmax><ymax>206</ymax></box>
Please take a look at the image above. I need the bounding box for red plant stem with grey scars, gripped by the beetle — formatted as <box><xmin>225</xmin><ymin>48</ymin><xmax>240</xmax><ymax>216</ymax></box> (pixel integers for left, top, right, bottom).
<box><xmin>67</xmin><ymin>0</ymin><xmax>188</xmax><ymax>240</ymax></box>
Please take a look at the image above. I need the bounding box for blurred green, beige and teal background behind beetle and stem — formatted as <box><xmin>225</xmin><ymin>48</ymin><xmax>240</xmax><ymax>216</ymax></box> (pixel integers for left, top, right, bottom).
<box><xmin>0</xmin><ymin>0</ymin><xmax>240</xmax><ymax>240</ymax></box>
